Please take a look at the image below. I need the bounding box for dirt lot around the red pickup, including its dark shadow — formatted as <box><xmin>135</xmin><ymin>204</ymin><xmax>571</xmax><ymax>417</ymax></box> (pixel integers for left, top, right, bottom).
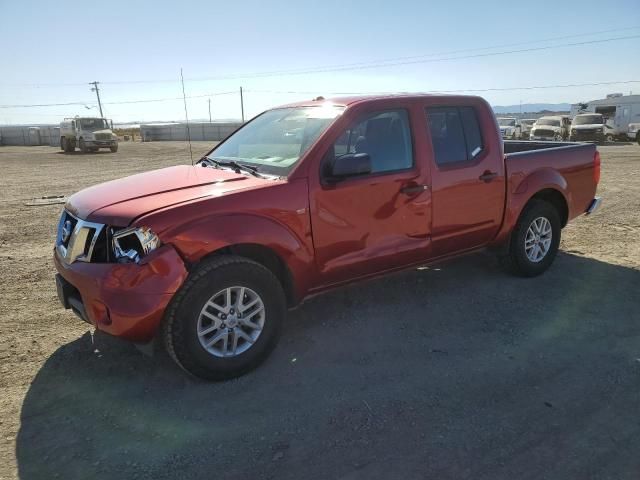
<box><xmin>0</xmin><ymin>142</ymin><xmax>640</xmax><ymax>480</ymax></box>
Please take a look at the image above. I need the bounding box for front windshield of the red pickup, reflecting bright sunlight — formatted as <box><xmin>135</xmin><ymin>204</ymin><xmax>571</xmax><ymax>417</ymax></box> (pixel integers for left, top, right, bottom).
<box><xmin>207</xmin><ymin>104</ymin><xmax>344</xmax><ymax>175</ymax></box>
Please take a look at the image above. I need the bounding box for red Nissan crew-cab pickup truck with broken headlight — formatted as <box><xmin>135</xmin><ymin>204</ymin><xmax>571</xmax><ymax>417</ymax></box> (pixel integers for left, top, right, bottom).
<box><xmin>54</xmin><ymin>95</ymin><xmax>600</xmax><ymax>379</ymax></box>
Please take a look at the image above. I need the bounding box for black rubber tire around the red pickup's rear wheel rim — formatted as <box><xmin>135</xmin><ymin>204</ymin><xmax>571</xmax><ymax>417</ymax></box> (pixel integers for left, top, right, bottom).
<box><xmin>500</xmin><ymin>200</ymin><xmax>562</xmax><ymax>277</ymax></box>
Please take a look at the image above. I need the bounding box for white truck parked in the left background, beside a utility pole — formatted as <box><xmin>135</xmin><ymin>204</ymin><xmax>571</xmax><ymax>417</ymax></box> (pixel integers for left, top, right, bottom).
<box><xmin>60</xmin><ymin>117</ymin><xmax>118</xmax><ymax>153</ymax></box>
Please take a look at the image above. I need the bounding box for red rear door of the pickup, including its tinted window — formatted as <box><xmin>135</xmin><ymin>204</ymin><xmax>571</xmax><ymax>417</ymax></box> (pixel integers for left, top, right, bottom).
<box><xmin>425</xmin><ymin>101</ymin><xmax>505</xmax><ymax>256</ymax></box>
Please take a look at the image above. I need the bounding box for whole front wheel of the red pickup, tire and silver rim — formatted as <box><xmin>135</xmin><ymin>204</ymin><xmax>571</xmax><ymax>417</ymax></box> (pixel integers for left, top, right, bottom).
<box><xmin>162</xmin><ymin>255</ymin><xmax>287</xmax><ymax>380</ymax></box>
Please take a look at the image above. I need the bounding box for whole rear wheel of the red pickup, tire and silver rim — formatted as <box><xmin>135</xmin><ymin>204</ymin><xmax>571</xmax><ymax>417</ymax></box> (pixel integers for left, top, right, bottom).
<box><xmin>501</xmin><ymin>200</ymin><xmax>562</xmax><ymax>277</ymax></box>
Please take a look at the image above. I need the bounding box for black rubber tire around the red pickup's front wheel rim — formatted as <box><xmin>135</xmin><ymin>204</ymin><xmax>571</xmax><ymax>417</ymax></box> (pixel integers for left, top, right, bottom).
<box><xmin>161</xmin><ymin>255</ymin><xmax>287</xmax><ymax>381</ymax></box>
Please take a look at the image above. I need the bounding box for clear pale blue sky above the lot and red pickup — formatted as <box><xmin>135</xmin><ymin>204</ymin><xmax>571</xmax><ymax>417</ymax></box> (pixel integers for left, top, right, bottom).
<box><xmin>0</xmin><ymin>0</ymin><xmax>640</xmax><ymax>124</ymax></box>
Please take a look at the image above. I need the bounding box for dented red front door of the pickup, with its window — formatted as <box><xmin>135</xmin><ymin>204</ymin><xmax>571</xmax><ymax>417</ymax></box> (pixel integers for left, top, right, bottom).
<box><xmin>310</xmin><ymin>109</ymin><xmax>431</xmax><ymax>285</ymax></box>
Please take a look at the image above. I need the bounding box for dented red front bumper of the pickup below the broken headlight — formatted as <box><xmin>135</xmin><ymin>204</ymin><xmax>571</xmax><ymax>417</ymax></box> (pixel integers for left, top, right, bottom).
<box><xmin>53</xmin><ymin>245</ymin><xmax>187</xmax><ymax>342</ymax></box>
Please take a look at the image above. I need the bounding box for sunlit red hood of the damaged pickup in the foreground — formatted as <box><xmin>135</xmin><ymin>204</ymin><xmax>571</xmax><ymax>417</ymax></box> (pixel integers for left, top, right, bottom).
<box><xmin>65</xmin><ymin>165</ymin><xmax>279</xmax><ymax>227</ymax></box>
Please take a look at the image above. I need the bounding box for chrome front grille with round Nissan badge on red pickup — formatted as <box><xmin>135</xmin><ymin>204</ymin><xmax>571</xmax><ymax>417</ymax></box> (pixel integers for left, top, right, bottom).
<box><xmin>56</xmin><ymin>210</ymin><xmax>106</xmax><ymax>263</ymax></box>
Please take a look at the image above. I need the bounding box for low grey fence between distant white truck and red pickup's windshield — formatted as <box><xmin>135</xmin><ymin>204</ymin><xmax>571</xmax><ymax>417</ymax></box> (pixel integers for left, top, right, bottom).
<box><xmin>140</xmin><ymin>122</ymin><xmax>242</xmax><ymax>142</ymax></box>
